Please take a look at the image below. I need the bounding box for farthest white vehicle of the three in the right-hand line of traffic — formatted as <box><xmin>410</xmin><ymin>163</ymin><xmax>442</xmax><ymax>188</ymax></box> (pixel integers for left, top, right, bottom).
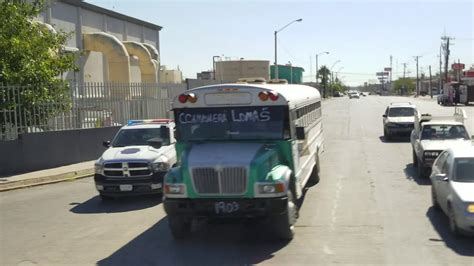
<box><xmin>382</xmin><ymin>103</ymin><xmax>417</xmax><ymax>140</ymax></box>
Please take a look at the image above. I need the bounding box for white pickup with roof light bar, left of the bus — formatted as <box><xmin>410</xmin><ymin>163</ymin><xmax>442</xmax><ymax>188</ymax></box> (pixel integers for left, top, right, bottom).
<box><xmin>94</xmin><ymin>119</ymin><xmax>176</xmax><ymax>200</ymax></box>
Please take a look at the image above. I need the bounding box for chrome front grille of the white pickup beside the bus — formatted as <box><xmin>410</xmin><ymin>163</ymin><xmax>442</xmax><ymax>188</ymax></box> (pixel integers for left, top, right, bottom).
<box><xmin>104</xmin><ymin>162</ymin><xmax>153</xmax><ymax>178</ymax></box>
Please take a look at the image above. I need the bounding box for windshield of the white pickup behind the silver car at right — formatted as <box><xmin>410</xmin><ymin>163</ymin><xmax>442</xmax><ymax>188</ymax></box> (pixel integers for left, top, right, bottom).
<box><xmin>421</xmin><ymin>125</ymin><xmax>469</xmax><ymax>140</ymax></box>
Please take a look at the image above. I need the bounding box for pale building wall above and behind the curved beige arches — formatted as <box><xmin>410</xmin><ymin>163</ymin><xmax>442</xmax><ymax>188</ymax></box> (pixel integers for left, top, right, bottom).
<box><xmin>44</xmin><ymin>0</ymin><xmax>160</xmax><ymax>83</ymax></box>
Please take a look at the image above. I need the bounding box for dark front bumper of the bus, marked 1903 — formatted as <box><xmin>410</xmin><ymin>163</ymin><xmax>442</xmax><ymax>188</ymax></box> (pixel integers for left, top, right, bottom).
<box><xmin>163</xmin><ymin>197</ymin><xmax>287</xmax><ymax>218</ymax></box>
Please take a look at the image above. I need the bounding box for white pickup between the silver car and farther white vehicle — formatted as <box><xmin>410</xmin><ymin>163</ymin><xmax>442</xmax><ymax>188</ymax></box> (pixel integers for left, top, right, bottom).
<box><xmin>410</xmin><ymin>108</ymin><xmax>471</xmax><ymax>178</ymax></box>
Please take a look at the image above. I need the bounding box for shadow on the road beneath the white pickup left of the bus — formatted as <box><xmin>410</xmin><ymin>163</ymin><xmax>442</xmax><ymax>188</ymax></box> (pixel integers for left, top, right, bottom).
<box><xmin>70</xmin><ymin>195</ymin><xmax>161</xmax><ymax>214</ymax></box>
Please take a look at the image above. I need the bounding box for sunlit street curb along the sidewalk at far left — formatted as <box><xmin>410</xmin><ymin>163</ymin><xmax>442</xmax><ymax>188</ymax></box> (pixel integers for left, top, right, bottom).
<box><xmin>0</xmin><ymin>169</ymin><xmax>94</xmax><ymax>192</ymax></box>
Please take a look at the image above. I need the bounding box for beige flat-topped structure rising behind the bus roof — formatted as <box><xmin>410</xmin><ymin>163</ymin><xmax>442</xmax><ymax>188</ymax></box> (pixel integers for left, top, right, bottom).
<box><xmin>216</xmin><ymin>60</ymin><xmax>270</xmax><ymax>82</ymax></box>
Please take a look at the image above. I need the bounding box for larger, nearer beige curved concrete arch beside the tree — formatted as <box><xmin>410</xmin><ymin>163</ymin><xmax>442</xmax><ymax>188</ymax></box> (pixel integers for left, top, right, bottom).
<box><xmin>83</xmin><ymin>32</ymin><xmax>130</xmax><ymax>83</ymax></box>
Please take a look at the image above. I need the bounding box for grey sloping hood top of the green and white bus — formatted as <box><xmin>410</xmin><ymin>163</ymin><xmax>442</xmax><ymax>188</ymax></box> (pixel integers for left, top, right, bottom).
<box><xmin>188</xmin><ymin>143</ymin><xmax>263</xmax><ymax>168</ymax></box>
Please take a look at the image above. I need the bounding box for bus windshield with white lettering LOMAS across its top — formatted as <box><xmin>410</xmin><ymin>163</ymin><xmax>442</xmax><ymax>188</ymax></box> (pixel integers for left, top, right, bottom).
<box><xmin>175</xmin><ymin>106</ymin><xmax>289</xmax><ymax>141</ymax></box>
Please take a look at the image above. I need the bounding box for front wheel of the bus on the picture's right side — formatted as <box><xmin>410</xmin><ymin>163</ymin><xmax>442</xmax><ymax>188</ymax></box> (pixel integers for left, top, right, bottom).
<box><xmin>273</xmin><ymin>191</ymin><xmax>298</xmax><ymax>240</ymax></box>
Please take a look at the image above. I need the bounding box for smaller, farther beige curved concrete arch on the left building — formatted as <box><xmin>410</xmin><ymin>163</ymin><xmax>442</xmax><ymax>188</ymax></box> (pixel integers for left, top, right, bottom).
<box><xmin>123</xmin><ymin>42</ymin><xmax>158</xmax><ymax>83</ymax></box>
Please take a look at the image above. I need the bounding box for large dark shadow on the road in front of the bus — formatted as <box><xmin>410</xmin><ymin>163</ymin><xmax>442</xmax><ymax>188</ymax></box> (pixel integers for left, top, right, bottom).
<box><xmin>97</xmin><ymin>217</ymin><xmax>288</xmax><ymax>266</ymax></box>
